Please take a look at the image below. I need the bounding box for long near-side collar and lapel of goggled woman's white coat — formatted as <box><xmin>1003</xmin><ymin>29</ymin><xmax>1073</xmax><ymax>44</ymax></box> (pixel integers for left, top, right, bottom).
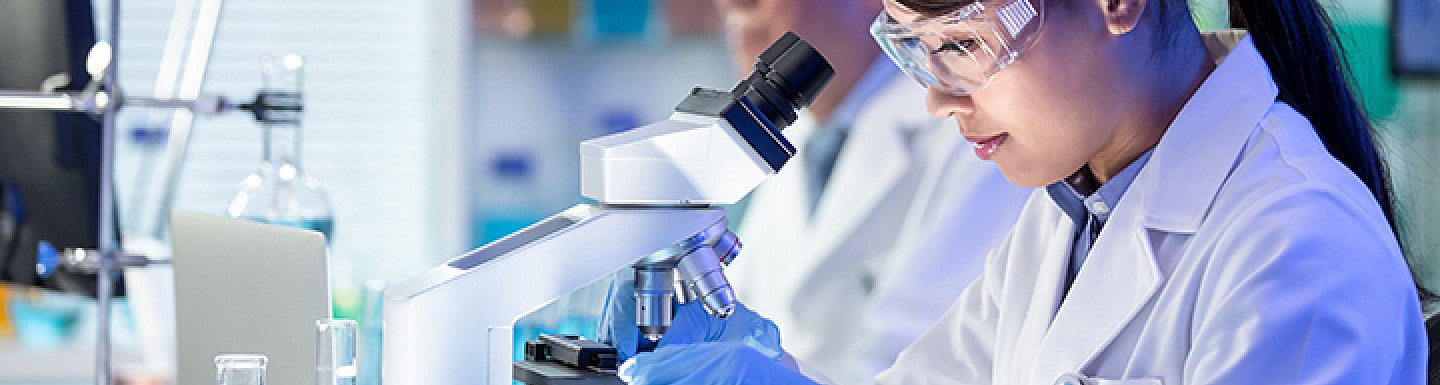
<box><xmin>1028</xmin><ymin>31</ymin><xmax>1277</xmax><ymax>384</ymax></box>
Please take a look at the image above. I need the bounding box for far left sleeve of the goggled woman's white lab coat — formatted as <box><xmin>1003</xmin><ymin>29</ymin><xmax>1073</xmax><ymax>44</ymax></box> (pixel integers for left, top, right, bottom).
<box><xmin>876</xmin><ymin>233</ymin><xmax>1011</xmax><ymax>385</ymax></box>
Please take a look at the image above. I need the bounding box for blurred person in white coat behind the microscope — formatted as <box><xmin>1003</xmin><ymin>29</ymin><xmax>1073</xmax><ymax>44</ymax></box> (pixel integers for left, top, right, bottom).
<box><xmin>716</xmin><ymin>0</ymin><xmax>1030</xmax><ymax>384</ymax></box>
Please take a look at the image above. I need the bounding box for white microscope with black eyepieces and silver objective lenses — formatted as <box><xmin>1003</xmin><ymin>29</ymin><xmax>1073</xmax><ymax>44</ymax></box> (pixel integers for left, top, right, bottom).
<box><xmin>383</xmin><ymin>33</ymin><xmax>834</xmax><ymax>385</ymax></box>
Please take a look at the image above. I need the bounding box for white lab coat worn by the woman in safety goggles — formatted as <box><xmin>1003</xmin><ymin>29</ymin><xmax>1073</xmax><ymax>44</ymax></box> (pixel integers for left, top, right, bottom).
<box><xmin>877</xmin><ymin>35</ymin><xmax>1427</xmax><ymax>385</ymax></box>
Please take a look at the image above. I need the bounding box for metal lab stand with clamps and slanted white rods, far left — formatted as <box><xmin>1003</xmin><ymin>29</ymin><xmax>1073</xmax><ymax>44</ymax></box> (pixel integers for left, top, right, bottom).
<box><xmin>0</xmin><ymin>0</ymin><xmax>289</xmax><ymax>385</ymax></box>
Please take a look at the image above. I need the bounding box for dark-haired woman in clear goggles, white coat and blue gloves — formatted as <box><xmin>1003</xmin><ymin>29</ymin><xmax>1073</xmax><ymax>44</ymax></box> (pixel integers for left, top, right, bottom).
<box><xmin>622</xmin><ymin>0</ymin><xmax>1427</xmax><ymax>385</ymax></box>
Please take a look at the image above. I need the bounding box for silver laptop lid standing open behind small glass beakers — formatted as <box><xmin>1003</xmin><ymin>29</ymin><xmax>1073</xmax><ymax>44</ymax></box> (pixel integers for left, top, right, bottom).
<box><xmin>170</xmin><ymin>212</ymin><xmax>331</xmax><ymax>384</ymax></box>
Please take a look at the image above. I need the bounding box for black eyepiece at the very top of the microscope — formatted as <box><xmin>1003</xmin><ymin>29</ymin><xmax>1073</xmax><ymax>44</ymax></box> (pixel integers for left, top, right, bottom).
<box><xmin>732</xmin><ymin>32</ymin><xmax>835</xmax><ymax>130</ymax></box>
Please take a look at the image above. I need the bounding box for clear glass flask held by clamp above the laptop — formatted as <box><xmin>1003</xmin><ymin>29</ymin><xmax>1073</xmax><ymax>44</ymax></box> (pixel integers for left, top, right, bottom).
<box><xmin>228</xmin><ymin>53</ymin><xmax>334</xmax><ymax>239</ymax></box>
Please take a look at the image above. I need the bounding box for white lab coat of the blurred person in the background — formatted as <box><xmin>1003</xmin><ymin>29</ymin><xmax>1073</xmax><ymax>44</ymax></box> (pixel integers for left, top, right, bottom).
<box><xmin>726</xmin><ymin>62</ymin><xmax>1030</xmax><ymax>384</ymax></box>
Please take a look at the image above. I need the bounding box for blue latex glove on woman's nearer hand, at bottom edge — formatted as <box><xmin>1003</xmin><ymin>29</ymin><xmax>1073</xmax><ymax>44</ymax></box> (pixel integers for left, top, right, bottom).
<box><xmin>619</xmin><ymin>342</ymin><xmax>816</xmax><ymax>385</ymax></box>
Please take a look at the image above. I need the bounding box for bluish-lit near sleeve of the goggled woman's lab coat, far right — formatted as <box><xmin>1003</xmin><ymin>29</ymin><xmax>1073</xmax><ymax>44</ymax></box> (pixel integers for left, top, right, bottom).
<box><xmin>1181</xmin><ymin>185</ymin><xmax>1426</xmax><ymax>385</ymax></box>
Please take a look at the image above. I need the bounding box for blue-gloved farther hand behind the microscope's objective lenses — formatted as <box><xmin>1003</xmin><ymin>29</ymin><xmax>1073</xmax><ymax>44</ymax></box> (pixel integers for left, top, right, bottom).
<box><xmin>598</xmin><ymin>268</ymin><xmax>785</xmax><ymax>362</ymax></box>
